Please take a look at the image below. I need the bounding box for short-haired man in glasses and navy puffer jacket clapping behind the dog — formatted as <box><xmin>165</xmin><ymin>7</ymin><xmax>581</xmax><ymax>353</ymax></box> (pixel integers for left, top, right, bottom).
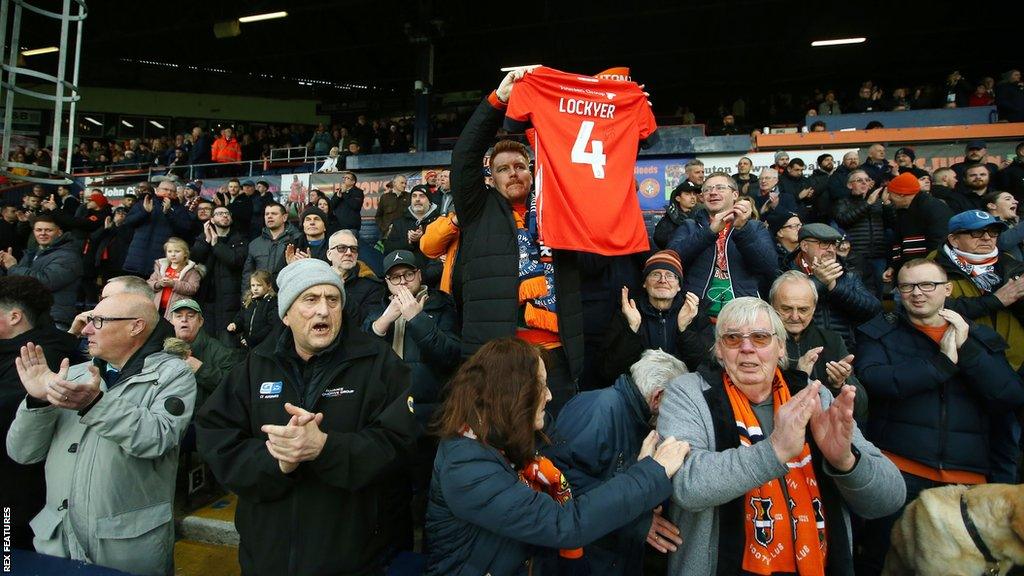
<box><xmin>855</xmin><ymin>258</ymin><xmax>1024</xmax><ymax>574</ymax></box>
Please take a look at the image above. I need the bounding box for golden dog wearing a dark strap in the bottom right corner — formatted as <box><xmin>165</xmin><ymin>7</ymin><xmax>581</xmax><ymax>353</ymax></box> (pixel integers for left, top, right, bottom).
<box><xmin>882</xmin><ymin>484</ymin><xmax>1024</xmax><ymax>576</ymax></box>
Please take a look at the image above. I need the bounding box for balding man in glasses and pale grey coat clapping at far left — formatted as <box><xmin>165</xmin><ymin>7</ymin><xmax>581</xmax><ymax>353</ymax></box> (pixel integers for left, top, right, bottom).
<box><xmin>7</xmin><ymin>293</ymin><xmax>196</xmax><ymax>575</ymax></box>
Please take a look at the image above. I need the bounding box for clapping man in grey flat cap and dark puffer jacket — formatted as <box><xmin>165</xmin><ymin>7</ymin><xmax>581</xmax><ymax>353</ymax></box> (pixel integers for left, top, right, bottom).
<box><xmin>782</xmin><ymin>222</ymin><xmax>882</xmax><ymax>349</ymax></box>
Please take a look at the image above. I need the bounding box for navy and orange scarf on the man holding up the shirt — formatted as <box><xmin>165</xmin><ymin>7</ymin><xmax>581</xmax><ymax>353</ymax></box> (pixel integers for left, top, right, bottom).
<box><xmin>513</xmin><ymin>195</ymin><xmax>558</xmax><ymax>333</ymax></box>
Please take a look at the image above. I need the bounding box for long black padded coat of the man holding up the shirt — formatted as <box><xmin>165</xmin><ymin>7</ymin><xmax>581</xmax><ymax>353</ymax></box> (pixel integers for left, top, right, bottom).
<box><xmin>452</xmin><ymin>100</ymin><xmax>583</xmax><ymax>378</ymax></box>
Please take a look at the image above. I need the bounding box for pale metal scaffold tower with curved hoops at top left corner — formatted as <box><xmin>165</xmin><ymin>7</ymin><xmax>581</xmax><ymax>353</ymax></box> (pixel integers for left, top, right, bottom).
<box><xmin>0</xmin><ymin>0</ymin><xmax>88</xmax><ymax>184</ymax></box>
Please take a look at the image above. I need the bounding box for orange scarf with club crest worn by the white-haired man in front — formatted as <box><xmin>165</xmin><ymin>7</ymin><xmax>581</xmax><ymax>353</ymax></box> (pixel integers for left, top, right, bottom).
<box><xmin>722</xmin><ymin>368</ymin><xmax>828</xmax><ymax>576</ymax></box>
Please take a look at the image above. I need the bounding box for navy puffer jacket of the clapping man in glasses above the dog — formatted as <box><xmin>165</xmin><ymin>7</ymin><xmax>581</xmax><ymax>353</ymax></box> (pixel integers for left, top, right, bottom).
<box><xmin>855</xmin><ymin>313</ymin><xmax>1024</xmax><ymax>476</ymax></box>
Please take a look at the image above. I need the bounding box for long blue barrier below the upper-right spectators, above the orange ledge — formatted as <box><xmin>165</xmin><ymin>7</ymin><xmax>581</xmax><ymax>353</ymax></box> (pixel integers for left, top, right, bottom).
<box><xmin>804</xmin><ymin>106</ymin><xmax>998</xmax><ymax>131</ymax></box>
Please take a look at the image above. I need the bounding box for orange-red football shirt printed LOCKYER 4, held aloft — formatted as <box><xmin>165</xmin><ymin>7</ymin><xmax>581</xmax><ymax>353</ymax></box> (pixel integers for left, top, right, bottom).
<box><xmin>506</xmin><ymin>67</ymin><xmax>657</xmax><ymax>256</ymax></box>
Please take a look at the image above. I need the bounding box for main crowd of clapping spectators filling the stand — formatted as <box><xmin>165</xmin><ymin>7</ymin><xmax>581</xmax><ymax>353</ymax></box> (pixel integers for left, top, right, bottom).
<box><xmin>0</xmin><ymin>65</ymin><xmax>1024</xmax><ymax>575</ymax></box>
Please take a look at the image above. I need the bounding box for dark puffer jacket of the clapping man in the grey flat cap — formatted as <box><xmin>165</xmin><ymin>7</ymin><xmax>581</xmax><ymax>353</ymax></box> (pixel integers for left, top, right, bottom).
<box><xmin>782</xmin><ymin>250</ymin><xmax>882</xmax><ymax>349</ymax></box>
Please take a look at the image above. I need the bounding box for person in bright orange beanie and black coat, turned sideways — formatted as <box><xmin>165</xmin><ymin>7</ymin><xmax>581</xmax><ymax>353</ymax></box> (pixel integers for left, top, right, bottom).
<box><xmin>882</xmin><ymin>172</ymin><xmax>953</xmax><ymax>282</ymax></box>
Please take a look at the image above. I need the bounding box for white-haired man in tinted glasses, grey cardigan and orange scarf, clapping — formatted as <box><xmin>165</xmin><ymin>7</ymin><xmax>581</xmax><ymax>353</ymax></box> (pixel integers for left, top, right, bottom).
<box><xmin>657</xmin><ymin>297</ymin><xmax>904</xmax><ymax>575</ymax></box>
